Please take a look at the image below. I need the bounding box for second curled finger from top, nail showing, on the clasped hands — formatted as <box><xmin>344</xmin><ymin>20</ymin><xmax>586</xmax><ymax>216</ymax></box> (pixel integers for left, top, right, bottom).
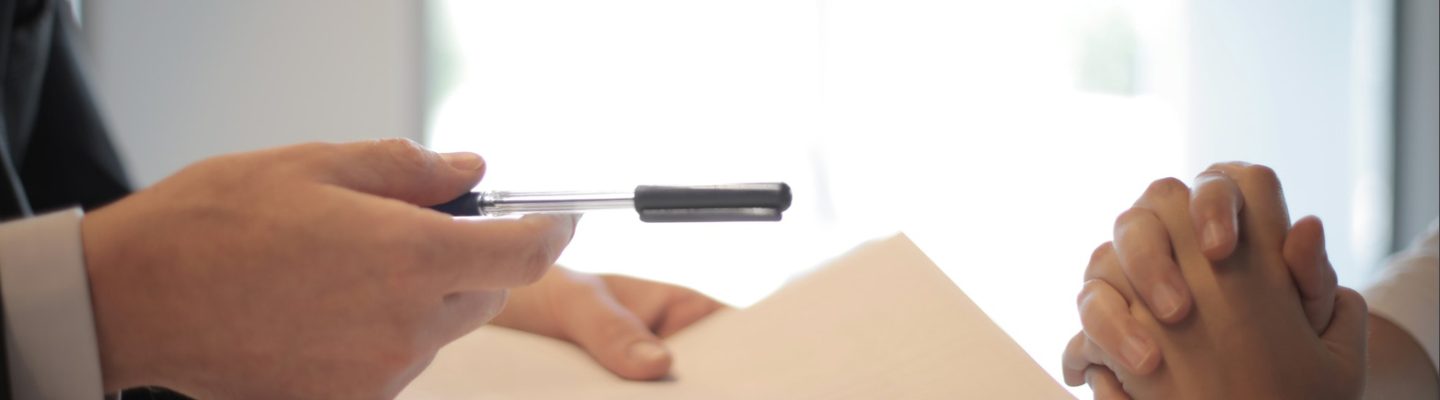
<box><xmin>1115</xmin><ymin>209</ymin><xmax>1191</xmax><ymax>322</ymax></box>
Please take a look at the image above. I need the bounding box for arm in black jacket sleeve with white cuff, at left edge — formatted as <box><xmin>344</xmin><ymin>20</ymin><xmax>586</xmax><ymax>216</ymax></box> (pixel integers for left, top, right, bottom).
<box><xmin>0</xmin><ymin>1</ymin><xmax>130</xmax><ymax>399</ymax></box>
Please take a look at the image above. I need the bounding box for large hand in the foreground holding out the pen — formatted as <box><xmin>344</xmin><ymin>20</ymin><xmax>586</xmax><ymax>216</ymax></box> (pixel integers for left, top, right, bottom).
<box><xmin>81</xmin><ymin>140</ymin><xmax>575</xmax><ymax>399</ymax></box>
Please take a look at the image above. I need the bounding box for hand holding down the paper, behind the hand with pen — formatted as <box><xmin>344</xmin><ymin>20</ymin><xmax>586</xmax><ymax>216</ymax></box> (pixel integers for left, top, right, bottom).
<box><xmin>494</xmin><ymin>268</ymin><xmax>724</xmax><ymax>380</ymax></box>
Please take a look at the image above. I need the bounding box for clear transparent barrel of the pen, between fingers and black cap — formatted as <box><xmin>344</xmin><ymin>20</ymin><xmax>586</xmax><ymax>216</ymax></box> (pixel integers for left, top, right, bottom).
<box><xmin>480</xmin><ymin>191</ymin><xmax>635</xmax><ymax>216</ymax></box>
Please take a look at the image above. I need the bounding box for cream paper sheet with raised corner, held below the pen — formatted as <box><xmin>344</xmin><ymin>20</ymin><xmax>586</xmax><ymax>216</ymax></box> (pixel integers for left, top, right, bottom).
<box><xmin>400</xmin><ymin>235</ymin><xmax>1071</xmax><ymax>399</ymax></box>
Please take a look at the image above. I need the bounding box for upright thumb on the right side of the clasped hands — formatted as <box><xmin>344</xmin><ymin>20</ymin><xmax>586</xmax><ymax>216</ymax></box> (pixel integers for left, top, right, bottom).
<box><xmin>1284</xmin><ymin>216</ymin><xmax>1339</xmax><ymax>334</ymax></box>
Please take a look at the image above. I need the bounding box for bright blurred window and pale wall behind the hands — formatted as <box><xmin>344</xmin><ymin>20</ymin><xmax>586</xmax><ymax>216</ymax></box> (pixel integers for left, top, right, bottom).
<box><xmin>78</xmin><ymin>0</ymin><xmax>1440</xmax><ymax>394</ymax></box>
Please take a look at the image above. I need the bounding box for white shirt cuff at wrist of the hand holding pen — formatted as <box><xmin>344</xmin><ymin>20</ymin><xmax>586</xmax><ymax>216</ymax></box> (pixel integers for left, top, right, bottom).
<box><xmin>0</xmin><ymin>209</ymin><xmax>104</xmax><ymax>399</ymax></box>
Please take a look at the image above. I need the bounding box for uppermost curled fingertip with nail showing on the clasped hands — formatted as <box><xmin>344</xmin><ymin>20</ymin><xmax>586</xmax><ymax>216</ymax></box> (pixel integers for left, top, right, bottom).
<box><xmin>1189</xmin><ymin>170</ymin><xmax>1246</xmax><ymax>260</ymax></box>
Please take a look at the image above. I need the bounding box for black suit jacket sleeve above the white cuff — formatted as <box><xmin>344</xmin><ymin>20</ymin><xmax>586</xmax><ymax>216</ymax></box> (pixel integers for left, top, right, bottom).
<box><xmin>0</xmin><ymin>0</ymin><xmax>130</xmax><ymax>399</ymax></box>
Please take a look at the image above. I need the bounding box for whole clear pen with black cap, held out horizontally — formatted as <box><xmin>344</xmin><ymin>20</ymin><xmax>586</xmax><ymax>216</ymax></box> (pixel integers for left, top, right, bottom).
<box><xmin>431</xmin><ymin>183</ymin><xmax>791</xmax><ymax>222</ymax></box>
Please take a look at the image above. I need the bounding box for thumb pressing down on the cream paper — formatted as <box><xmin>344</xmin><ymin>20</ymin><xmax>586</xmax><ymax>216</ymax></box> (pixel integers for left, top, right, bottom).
<box><xmin>560</xmin><ymin>276</ymin><xmax>672</xmax><ymax>380</ymax></box>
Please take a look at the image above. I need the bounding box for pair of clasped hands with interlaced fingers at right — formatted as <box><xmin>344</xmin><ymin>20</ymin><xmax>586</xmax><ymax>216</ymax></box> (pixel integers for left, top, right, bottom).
<box><xmin>1064</xmin><ymin>163</ymin><xmax>1367</xmax><ymax>399</ymax></box>
